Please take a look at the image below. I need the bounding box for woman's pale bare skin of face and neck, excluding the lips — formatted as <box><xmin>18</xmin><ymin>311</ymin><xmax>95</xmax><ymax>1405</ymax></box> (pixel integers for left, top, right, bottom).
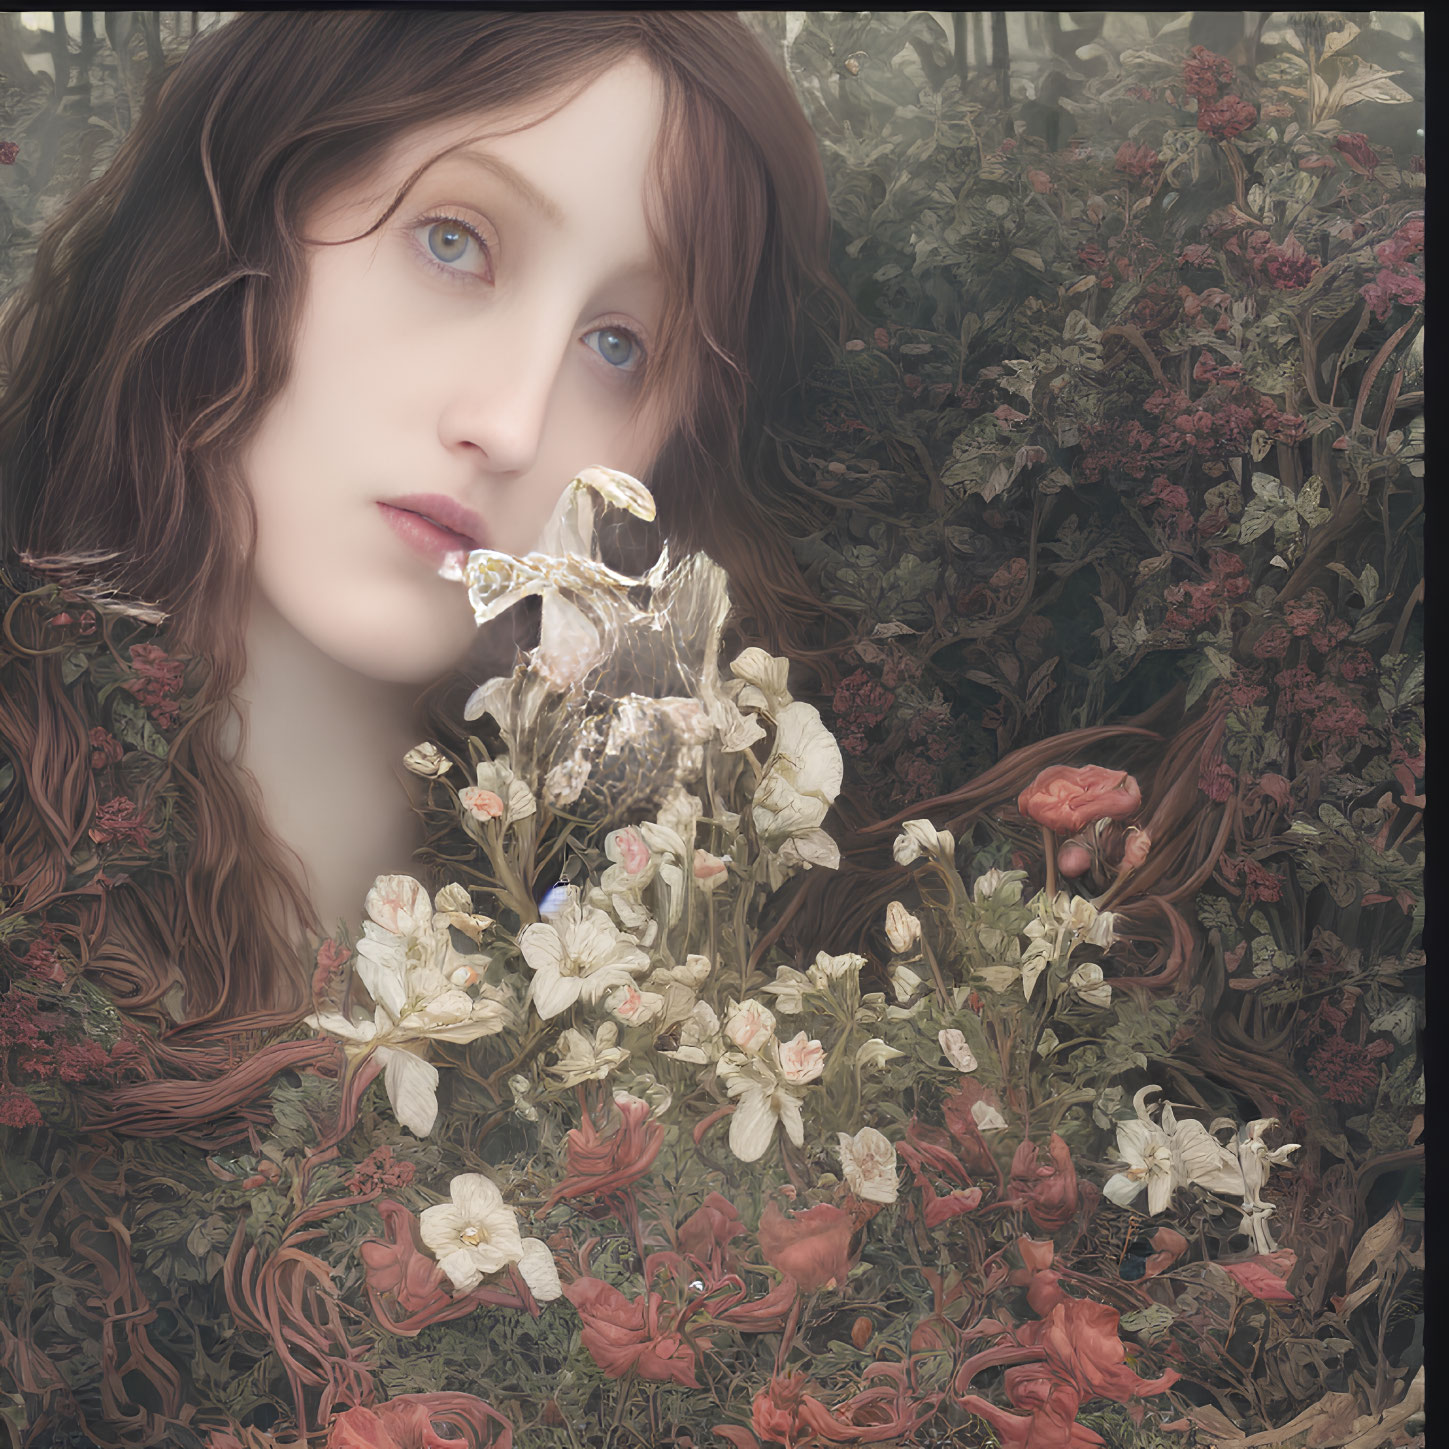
<box><xmin>238</xmin><ymin>59</ymin><xmax>668</xmax><ymax>932</ymax></box>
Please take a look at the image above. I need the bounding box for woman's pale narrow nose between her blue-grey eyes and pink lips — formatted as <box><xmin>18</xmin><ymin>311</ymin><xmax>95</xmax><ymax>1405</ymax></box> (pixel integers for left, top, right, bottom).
<box><xmin>438</xmin><ymin>317</ymin><xmax>564</xmax><ymax>477</ymax></box>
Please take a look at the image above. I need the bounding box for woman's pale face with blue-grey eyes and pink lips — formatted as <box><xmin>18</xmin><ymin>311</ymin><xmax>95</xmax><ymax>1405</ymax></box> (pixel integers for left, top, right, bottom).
<box><xmin>245</xmin><ymin>61</ymin><xmax>669</xmax><ymax>684</ymax></box>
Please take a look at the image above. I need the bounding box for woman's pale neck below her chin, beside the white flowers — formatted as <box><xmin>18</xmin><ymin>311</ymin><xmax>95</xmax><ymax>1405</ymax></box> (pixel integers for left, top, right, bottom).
<box><xmin>236</xmin><ymin>596</ymin><xmax>422</xmax><ymax>933</ymax></box>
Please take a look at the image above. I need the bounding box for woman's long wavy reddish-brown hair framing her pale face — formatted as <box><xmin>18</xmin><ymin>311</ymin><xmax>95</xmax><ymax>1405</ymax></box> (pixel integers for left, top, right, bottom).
<box><xmin>0</xmin><ymin>9</ymin><xmax>838</xmax><ymax>1033</ymax></box>
